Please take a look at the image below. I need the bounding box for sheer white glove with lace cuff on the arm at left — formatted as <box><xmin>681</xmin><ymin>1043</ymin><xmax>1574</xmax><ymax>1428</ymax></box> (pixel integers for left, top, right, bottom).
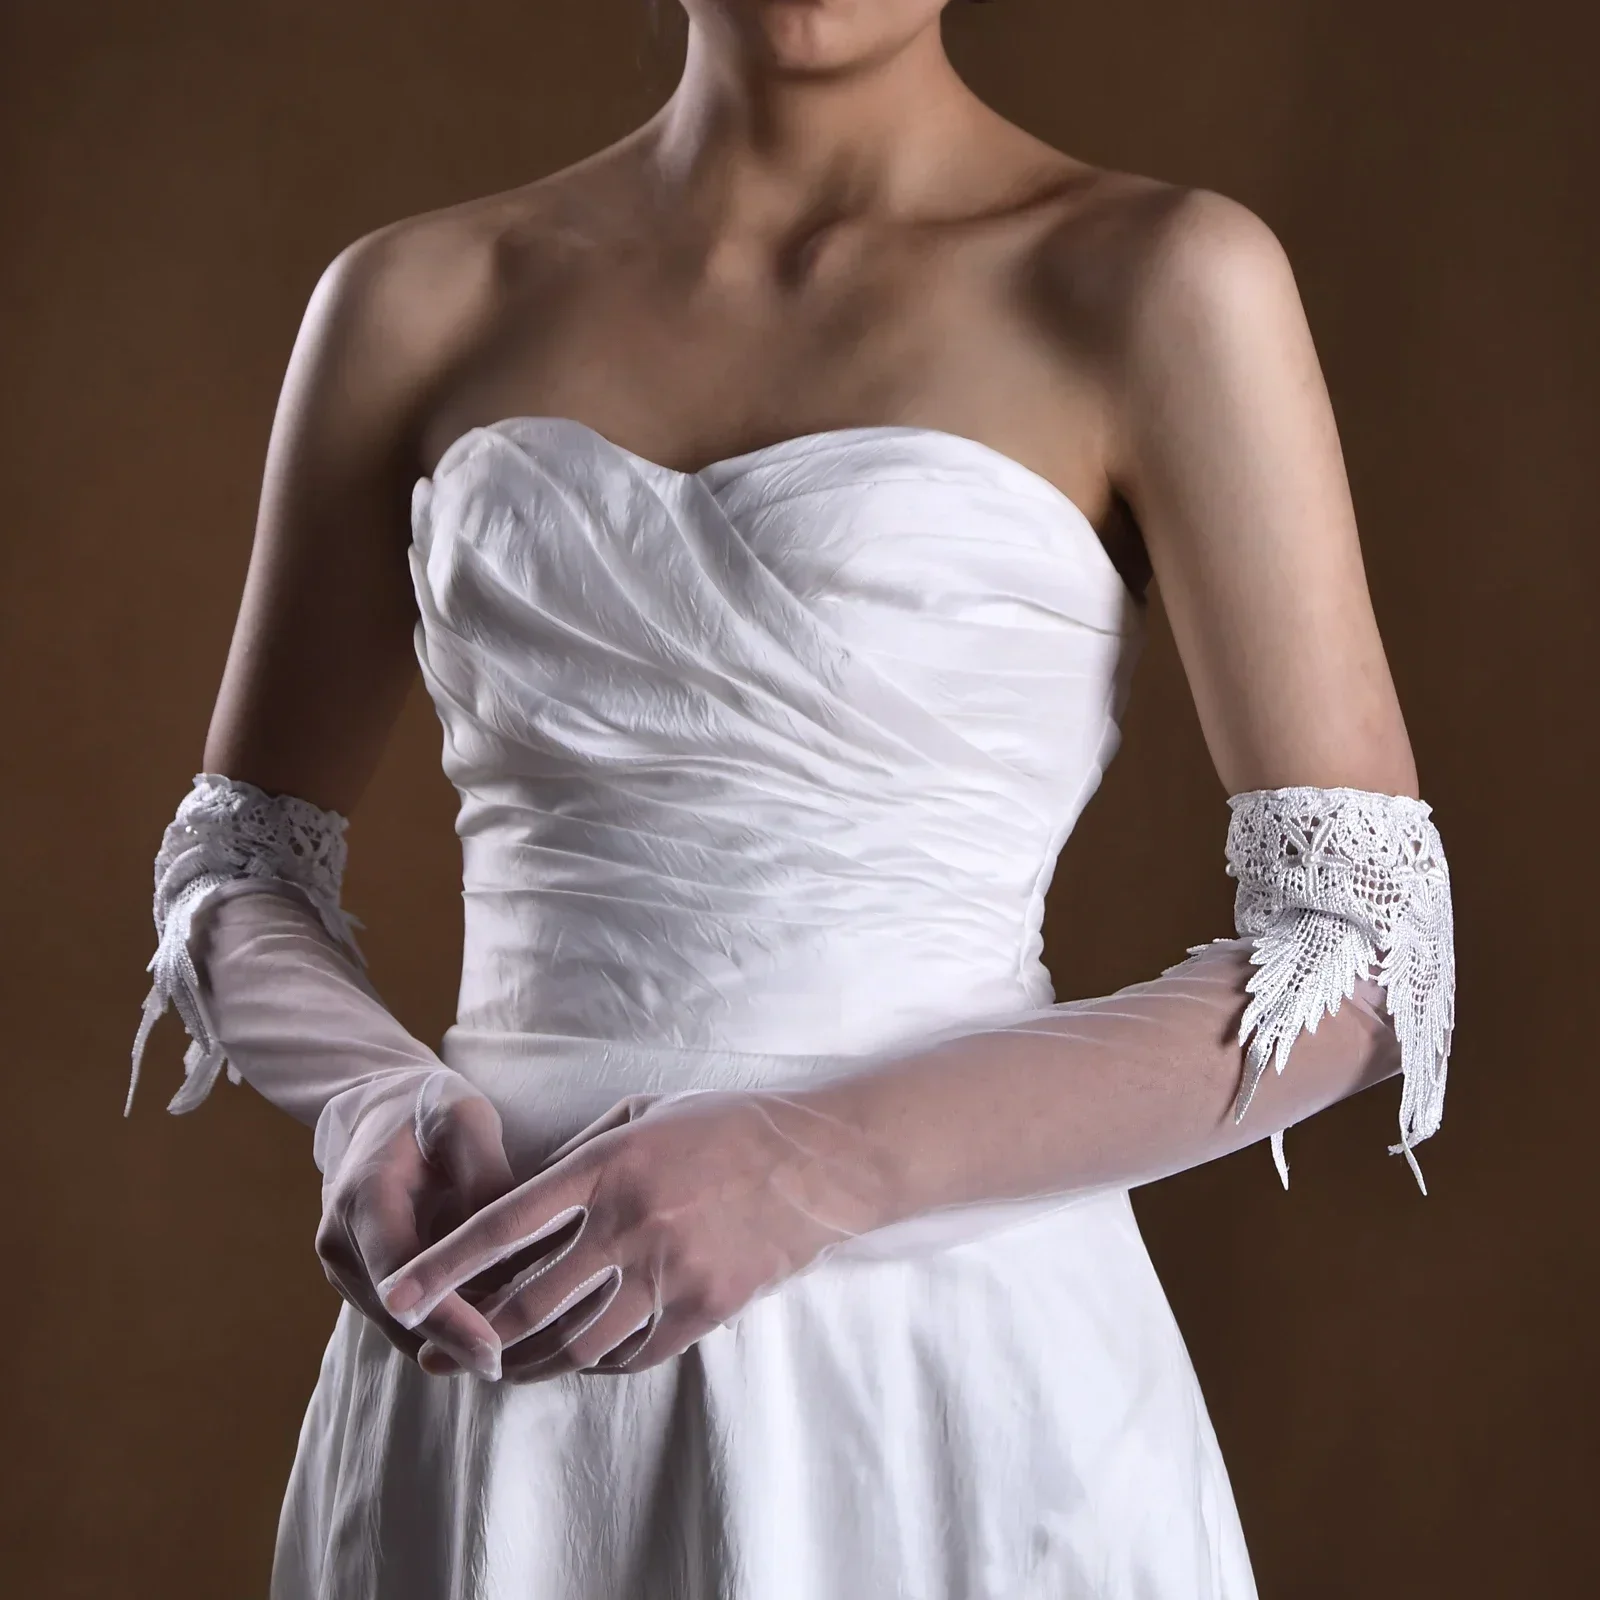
<box><xmin>135</xmin><ymin>773</ymin><xmax>512</xmax><ymax>1370</ymax></box>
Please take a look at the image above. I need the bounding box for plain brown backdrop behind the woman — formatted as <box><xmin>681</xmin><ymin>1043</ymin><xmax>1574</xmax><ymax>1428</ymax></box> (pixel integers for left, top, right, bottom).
<box><xmin>0</xmin><ymin>0</ymin><xmax>1600</xmax><ymax>1600</ymax></box>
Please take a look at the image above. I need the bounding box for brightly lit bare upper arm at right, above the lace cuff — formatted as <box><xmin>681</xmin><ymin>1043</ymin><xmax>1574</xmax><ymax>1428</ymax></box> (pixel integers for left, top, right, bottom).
<box><xmin>1112</xmin><ymin>194</ymin><xmax>1418</xmax><ymax>797</ymax></box>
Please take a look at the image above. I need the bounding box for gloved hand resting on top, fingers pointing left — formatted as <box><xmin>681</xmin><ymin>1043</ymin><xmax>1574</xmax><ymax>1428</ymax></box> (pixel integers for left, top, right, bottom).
<box><xmin>379</xmin><ymin>1090</ymin><xmax>888</xmax><ymax>1382</ymax></box>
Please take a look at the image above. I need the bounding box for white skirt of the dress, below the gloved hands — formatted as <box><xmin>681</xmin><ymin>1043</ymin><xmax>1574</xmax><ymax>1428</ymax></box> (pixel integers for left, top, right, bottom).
<box><xmin>270</xmin><ymin>1035</ymin><xmax>1256</xmax><ymax>1600</ymax></box>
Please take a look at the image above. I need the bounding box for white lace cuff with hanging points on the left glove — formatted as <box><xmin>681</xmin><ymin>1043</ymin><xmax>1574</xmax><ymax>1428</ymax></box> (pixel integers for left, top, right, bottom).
<box><xmin>123</xmin><ymin>773</ymin><xmax>365</xmax><ymax>1115</ymax></box>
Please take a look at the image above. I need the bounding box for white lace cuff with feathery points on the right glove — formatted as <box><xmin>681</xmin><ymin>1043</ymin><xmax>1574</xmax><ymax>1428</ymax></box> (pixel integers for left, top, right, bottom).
<box><xmin>1189</xmin><ymin>787</ymin><xmax>1456</xmax><ymax>1194</ymax></box>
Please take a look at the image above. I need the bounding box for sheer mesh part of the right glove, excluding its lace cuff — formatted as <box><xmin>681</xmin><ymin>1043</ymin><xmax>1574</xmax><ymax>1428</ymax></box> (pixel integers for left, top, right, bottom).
<box><xmin>368</xmin><ymin>939</ymin><xmax>1400</xmax><ymax>1381</ymax></box>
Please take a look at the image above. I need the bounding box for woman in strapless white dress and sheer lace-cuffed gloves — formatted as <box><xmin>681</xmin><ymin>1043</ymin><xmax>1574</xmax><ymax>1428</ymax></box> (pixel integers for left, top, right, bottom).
<box><xmin>130</xmin><ymin>0</ymin><xmax>1453</xmax><ymax>1600</ymax></box>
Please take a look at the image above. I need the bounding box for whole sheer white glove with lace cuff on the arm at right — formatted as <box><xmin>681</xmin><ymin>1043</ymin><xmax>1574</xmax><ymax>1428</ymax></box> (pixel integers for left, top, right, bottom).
<box><xmin>381</xmin><ymin>790</ymin><xmax>1454</xmax><ymax>1379</ymax></box>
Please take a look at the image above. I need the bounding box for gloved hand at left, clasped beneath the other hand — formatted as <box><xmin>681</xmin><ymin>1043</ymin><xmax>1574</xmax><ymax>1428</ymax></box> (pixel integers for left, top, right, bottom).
<box><xmin>317</xmin><ymin>1066</ymin><xmax>514</xmax><ymax>1379</ymax></box>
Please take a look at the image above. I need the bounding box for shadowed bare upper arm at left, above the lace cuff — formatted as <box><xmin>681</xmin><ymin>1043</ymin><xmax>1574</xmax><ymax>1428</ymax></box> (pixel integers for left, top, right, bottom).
<box><xmin>205</xmin><ymin>219</ymin><xmax>464</xmax><ymax>813</ymax></box>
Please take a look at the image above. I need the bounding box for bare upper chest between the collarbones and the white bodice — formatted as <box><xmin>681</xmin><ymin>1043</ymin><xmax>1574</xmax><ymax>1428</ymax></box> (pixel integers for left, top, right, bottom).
<box><xmin>434</xmin><ymin>211</ymin><xmax>1112</xmax><ymax>522</ymax></box>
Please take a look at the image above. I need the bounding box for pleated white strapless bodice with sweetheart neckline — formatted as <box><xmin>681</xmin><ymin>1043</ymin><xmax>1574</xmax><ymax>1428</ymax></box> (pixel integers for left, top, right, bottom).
<box><xmin>411</xmin><ymin>418</ymin><xmax>1142</xmax><ymax>1054</ymax></box>
